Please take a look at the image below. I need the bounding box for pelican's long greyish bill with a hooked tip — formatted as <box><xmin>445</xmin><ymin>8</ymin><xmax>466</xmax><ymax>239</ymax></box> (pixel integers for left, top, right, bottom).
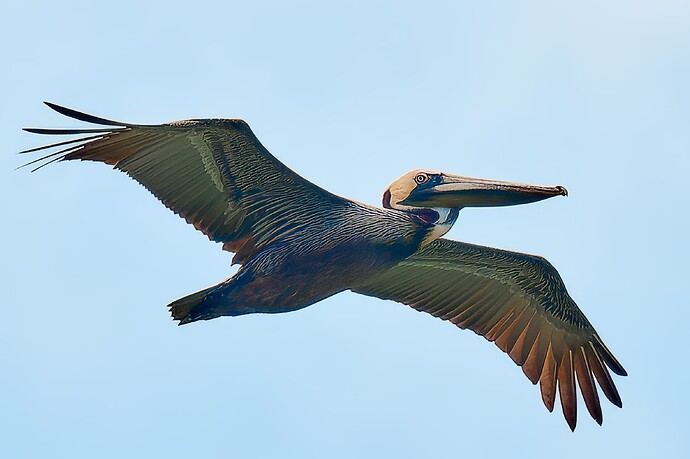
<box><xmin>401</xmin><ymin>174</ymin><xmax>568</xmax><ymax>209</ymax></box>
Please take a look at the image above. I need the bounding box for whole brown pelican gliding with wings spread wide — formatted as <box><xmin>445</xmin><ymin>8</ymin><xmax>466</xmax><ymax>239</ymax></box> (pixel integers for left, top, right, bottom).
<box><xmin>24</xmin><ymin>103</ymin><xmax>626</xmax><ymax>430</ymax></box>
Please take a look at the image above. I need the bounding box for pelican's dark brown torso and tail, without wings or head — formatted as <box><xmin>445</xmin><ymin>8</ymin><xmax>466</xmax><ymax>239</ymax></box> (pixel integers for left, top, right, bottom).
<box><xmin>177</xmin><ymin>205</ymin><xmax>424</xmax><ymax>323</ymax></box>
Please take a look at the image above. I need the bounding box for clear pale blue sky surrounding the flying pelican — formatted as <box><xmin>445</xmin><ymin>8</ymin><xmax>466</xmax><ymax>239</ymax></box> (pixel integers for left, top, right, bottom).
<box><xmin>0</xmin><ymin>0</ymin><xmax>690</xmax><ymax>458</ymax></box>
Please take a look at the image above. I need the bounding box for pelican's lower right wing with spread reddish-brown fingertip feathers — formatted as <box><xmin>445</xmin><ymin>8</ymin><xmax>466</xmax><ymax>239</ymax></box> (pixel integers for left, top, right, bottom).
<box><xmin>353</xmin><ymin>239</ymin><xmax>626</xmax><ymax>430</ymax></box>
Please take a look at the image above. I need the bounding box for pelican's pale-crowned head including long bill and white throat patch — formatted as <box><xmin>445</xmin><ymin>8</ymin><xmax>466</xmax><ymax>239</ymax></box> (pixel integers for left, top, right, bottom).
<box><xmin>383</xmin><ymin>170</ymin><xmax>568</xmax><ymax>243</ymax></box>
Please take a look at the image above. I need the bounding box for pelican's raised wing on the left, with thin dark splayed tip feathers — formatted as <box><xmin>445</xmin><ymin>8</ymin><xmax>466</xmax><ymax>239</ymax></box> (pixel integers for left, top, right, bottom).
<box><xmin>22</xmin><ymin>102</ymin><xmax>349</xmax><ymax>263</ymax></box>
